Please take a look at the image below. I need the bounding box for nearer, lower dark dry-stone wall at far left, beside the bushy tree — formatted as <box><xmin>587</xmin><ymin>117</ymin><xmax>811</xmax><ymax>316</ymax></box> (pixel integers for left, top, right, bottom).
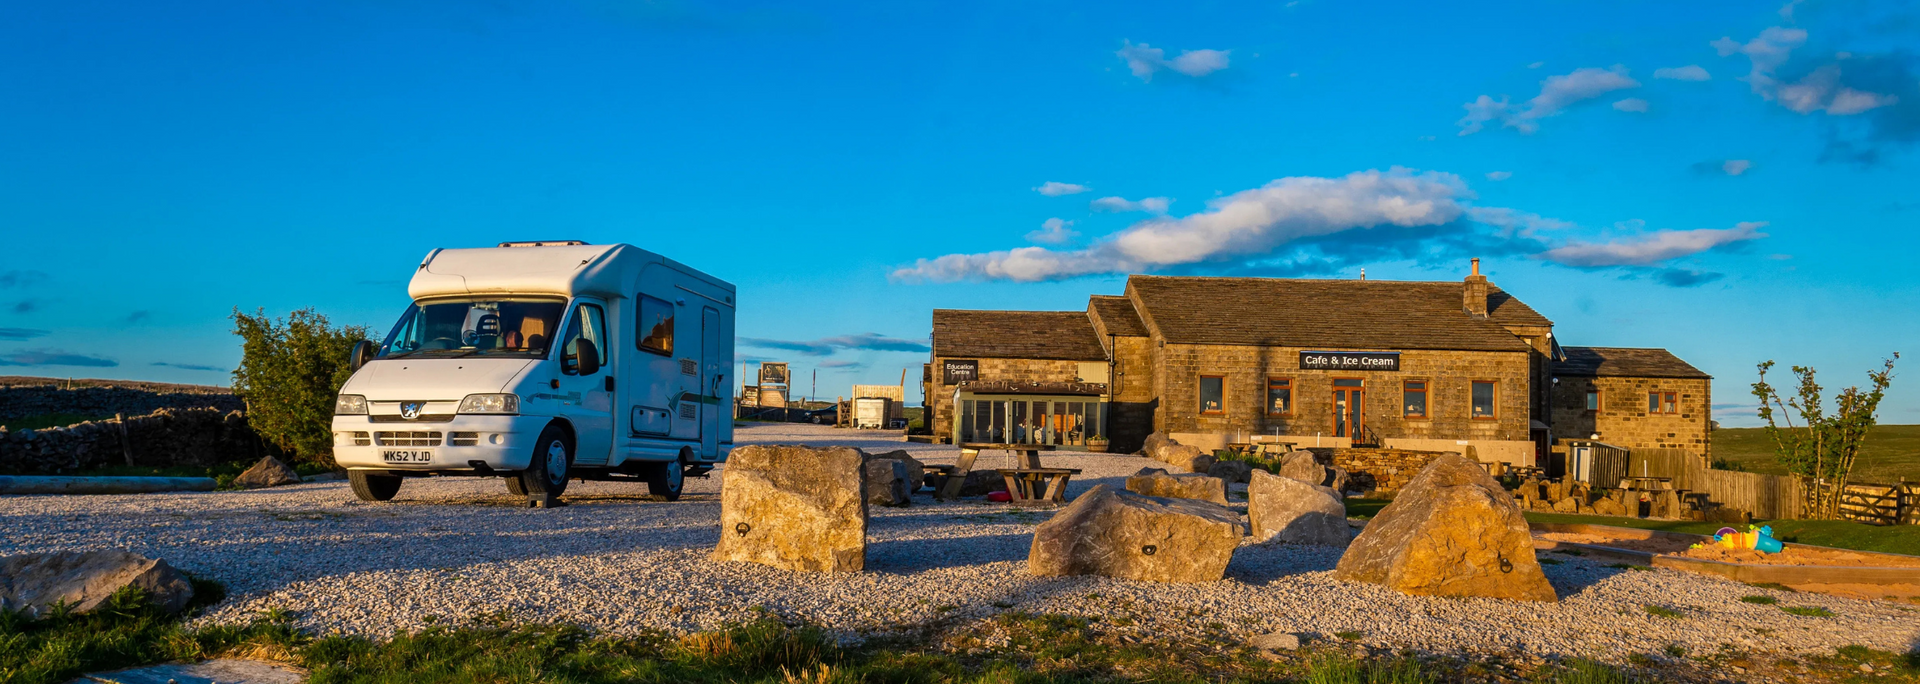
<box><xmin>0</xmin><ymin>407</ymin><xmax>265</xmax><ymax>475</ymax></box>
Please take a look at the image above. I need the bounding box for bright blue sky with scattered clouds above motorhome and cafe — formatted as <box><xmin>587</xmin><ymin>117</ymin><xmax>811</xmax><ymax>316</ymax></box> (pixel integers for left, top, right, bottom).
<box><xmin>0</xmin><ymin>0</ymin><xmax>1920</xmax><ymax>425</ymax></box>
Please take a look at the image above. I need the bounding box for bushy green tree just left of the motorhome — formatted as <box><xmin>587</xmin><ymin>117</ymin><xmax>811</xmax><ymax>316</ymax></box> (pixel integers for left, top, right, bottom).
<box><xmin>232</xmin><ymin>307</ymin><xmax>367</xmax><ymax>465</ymax></box>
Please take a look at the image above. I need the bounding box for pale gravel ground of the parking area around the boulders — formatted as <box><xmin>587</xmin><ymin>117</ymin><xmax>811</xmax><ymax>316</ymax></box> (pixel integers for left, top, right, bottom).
<box><xmin>0</xmin><ymin>425</ymin><xmax>1920</xmax><ymax>661</ymax></box>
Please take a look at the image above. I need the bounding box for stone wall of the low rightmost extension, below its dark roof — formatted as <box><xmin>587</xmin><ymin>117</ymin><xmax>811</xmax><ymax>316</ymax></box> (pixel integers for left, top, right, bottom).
<box><xmin>1553</xmin><ymin>377</ymin><xmax>1713</xmax><ymax>461</ymax></box>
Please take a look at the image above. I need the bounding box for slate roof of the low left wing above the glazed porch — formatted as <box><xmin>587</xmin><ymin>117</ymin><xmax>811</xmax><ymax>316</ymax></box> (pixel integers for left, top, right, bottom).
<box><xmin>933</xmin><ymin>309</ymin><xmax>1106</xmax><ymax>361</ymax></box>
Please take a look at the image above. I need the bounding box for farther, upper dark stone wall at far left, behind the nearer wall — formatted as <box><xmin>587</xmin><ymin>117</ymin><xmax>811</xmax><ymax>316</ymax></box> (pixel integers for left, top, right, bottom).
<box><xmin>0</xmin><ymin>377</ymin><xmax>246</xmax><ymax>425</ymax></box>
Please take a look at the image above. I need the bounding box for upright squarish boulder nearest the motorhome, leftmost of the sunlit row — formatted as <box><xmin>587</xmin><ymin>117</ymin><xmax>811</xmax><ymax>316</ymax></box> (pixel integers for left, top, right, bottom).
<box><xmin>712</xmin><ymin>446</ymin><xmax>866</xmax><ymax>573</ymax></box>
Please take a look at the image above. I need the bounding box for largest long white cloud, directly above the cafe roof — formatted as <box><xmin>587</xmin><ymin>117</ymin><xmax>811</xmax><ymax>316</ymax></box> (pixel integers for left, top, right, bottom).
<box><xmin>893</xmin><ymin>169</ymin><xmax>1471</xmax><ymax>282</ymax></box>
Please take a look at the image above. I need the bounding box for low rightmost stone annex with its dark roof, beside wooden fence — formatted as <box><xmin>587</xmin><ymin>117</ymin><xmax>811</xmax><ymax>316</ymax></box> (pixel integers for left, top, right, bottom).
<box><xmin>1553</xmin><ymin>346</ymin><xmax>1713</xmax><ymax>459</ymax></box>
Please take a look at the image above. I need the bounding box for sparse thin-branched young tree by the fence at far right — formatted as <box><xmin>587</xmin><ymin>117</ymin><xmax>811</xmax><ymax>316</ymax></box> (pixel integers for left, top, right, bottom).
<box><xmin>1753</xmin><ymin>352</ymin><xmax>1901</xmax><ymax>519</ymax></box>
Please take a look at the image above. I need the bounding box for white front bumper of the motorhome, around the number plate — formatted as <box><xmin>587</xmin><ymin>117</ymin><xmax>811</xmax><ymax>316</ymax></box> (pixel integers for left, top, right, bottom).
<box><xmin>334</xmin><ymin>415</ymin><xmax>553</xmax><ymax>473</ymax></box>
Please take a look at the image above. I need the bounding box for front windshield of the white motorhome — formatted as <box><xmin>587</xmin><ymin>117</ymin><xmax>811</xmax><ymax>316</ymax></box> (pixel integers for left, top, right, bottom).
<box><xmin>380</xmin><ymin>300</ymin><xmax>566</xmax><ymax>359</ymax></box>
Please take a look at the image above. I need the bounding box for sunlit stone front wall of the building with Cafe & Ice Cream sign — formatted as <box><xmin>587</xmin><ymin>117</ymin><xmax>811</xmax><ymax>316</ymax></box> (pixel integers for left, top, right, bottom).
<box><xmin>1152</xmin><ymin>344</ymin><xmax>1534</xmax><ymax>440</ymax></box>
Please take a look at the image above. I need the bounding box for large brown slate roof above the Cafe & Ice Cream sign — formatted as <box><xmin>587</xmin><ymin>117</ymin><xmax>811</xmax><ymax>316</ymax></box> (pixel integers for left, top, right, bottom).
<box><xmin>1127</xmin><ymin>275</ymin><xmax>1553</xmax><ymax>352</ymax></box>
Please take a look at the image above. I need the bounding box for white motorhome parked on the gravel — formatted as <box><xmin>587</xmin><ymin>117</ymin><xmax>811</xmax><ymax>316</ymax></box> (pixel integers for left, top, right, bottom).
<box><xmin>334</xmin><ymin>240</ymin><xmax>733</xmax><ymax>505</ymax></box>
